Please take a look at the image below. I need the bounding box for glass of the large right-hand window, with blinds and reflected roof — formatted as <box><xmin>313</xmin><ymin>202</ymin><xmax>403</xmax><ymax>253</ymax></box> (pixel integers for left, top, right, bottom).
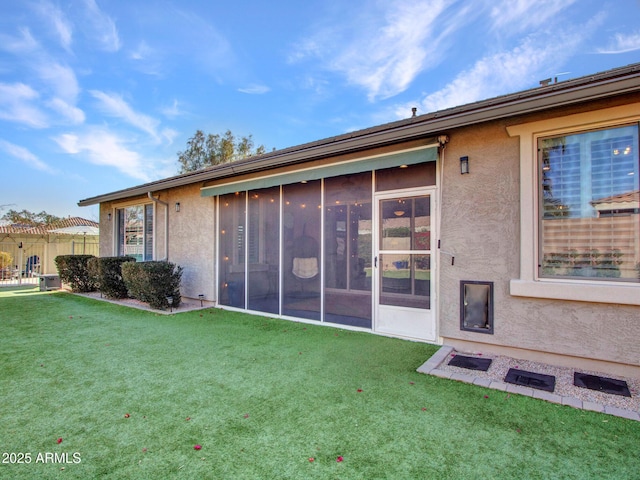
<box><xmin>538</xmin><ymin>124</ymin><xmax>640</xmax><ymax>282</ymax></box>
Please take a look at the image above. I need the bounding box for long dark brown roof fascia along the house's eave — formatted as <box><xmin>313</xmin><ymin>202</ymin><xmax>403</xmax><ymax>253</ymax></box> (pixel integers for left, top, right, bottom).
<box><xmin>78</xmin><ymin>68</ymin><xmax>640</xmax><ymax>207</ymax></box>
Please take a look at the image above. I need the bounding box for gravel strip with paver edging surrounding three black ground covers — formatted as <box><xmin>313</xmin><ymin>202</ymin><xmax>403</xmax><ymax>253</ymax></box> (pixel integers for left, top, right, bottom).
<box><xmin>418</xmin><ymin>346</ymin><xmax>640</xmax><ymax>421</ymax></box>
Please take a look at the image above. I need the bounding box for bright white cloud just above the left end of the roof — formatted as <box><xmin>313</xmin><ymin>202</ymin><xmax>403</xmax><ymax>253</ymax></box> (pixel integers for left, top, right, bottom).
<box><xmin>54</xmin><ymin>128</ymin><xmax>151</xmax><ymax>182</ymax></box>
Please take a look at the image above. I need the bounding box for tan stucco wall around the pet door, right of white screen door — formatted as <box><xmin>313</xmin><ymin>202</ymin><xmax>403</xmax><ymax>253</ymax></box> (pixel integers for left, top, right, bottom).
<box><xmin>439</xmin><ymin>117</ymin><xmax>640</xmax><ymax>373</ymax></box>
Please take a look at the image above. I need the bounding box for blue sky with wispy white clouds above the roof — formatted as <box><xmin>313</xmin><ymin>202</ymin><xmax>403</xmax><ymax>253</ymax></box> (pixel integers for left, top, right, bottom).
<box><xmin>0</xmin><ymin>0</ymin><xmax>640</xmax><ymax>219</ymax></box>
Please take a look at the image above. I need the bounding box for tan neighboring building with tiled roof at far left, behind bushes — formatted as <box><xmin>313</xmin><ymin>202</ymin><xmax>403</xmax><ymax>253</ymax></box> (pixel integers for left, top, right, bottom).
<box><xmin>0</xmin><ymin>217</ymin><xmax>99</xmax><ymax>285</ymax></box>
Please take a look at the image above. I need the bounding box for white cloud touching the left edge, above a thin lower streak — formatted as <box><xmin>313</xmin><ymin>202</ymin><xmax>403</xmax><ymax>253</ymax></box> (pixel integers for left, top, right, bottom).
<box><xmin>0</xmin><ymin>83</ymin><xmax>49</xmax><ymax>128</ymax></box>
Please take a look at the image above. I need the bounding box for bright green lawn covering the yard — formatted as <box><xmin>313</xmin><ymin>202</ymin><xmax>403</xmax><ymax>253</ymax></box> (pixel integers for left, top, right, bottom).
<box><xmin>0</xmin><ymin>289</ymin><xmax>640</xmax><ymax>480</ymax></box>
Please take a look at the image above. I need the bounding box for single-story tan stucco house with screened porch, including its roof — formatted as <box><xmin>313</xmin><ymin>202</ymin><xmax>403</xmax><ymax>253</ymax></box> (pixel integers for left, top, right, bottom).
<box><xmin>79</xmin><ymin>64</ymin><xmax>640</xmax><ymax>376</ymax></box>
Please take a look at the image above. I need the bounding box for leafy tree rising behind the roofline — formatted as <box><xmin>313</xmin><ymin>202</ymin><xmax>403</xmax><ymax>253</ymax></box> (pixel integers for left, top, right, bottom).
<box><xmin>178</xmin><ymin>130</ymin><xmax>265</xmax><ymax>173</ymax></box>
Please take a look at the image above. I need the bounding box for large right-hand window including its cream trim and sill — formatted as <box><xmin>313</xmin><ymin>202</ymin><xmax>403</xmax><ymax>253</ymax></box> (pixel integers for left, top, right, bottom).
<box><xmin>507</xmin><ymin>103</ymin><xmax>640</xmax><ymax>305</ymax></box>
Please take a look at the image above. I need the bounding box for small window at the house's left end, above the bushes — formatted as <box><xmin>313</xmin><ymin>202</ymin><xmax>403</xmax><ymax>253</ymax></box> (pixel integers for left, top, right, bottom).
<box><xmin>116</xmin><ymin>204</ymin><xmax>153</xmax><ymax>262</ymax></box>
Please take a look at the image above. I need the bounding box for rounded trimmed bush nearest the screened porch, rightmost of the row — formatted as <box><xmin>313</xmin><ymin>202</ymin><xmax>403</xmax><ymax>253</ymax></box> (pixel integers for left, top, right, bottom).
<box><xmin>122</xmin><ymin>261</ymin><xmax>182</xmax><ymax>310</ymax></box>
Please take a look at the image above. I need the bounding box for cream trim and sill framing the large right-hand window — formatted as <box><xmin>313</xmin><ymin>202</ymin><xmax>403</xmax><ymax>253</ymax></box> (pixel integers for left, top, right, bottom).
<box><xmin>507</xmin><ymin>103</ymin><xmax>640</xmax><ymax>305</ymax></box>
